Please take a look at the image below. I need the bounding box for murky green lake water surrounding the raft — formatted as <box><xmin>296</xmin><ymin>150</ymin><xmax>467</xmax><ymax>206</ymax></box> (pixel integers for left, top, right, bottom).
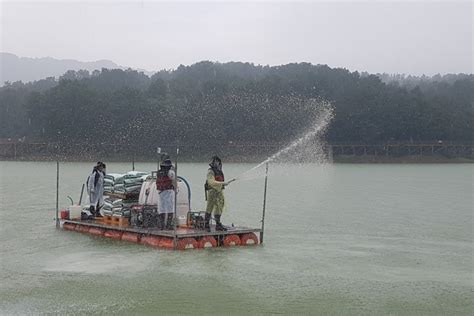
<box><xmin>0</xmin><ymin>162</ymin><xmax>474</xmax><ymax>315</ymax></box>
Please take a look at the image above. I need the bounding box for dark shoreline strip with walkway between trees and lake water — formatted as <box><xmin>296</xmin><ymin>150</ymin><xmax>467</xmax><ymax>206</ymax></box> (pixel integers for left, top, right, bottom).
<box><xmin>0</xmin><ymin>142</ymin><xmax>474</xmax><ymax>164</ymax></box>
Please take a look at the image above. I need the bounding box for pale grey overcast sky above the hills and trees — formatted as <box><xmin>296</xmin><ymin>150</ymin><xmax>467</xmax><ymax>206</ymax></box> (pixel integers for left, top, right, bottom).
<box><xmin>0</xmin><ymin>0</ymin><xmax>473</xmax><ymax>75</ymax></box>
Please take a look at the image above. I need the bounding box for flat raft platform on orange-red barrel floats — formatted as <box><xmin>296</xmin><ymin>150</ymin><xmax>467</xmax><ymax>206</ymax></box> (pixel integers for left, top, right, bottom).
<box><xmin>63</xmin><ymin>219</ymin><xmax>262</xmax><ymax>250</ymax></box>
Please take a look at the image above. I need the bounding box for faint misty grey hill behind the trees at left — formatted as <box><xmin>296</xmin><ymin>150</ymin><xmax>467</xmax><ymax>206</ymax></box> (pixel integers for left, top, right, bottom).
<box><xmin>0</xmin><ymin>52</ymin><xmax>123</xmax><ymax>85</ymax></box>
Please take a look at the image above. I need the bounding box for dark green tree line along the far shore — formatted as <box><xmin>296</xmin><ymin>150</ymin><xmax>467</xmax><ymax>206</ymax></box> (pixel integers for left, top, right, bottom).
<box><xmin>0</xmin><ymin>61</ymin><xmax>474</xmax><ymax>153</ymax></box>
